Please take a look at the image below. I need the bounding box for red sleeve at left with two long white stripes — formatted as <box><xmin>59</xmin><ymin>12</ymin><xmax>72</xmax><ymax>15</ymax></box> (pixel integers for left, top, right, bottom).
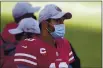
<box><xmin>14</xmin><ymin>41</ymin><xmax>37</xmax><ymax>68</ymax></box>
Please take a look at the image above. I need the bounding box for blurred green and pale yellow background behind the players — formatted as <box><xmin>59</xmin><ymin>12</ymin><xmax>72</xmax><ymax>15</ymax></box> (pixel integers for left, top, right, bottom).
<box><xmin>0</xmin><ymin>2</ymin><xmax>102</xmax><ymax>68</ymax></box>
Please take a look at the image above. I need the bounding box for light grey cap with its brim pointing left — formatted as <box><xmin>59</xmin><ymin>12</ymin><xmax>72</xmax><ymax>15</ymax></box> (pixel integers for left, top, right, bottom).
<box><xmin>9</xmin><ymin>18</ymin><xmax>40</xmax><ymax>34</ymax></box>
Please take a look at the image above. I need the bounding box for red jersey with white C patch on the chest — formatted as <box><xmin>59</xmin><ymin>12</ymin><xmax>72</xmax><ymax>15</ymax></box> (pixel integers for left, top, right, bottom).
<box><xmin>14</xmin><ymin>37</ymin><xmax>74</xmax><ymax>68</ymax></box>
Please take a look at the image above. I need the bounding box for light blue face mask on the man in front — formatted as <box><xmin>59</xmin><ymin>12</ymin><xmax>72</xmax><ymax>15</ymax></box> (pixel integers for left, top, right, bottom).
<box><xmin>51</xmin><ymin>24</ymin><xmax>65</xmax><ymax>38</ymax></box>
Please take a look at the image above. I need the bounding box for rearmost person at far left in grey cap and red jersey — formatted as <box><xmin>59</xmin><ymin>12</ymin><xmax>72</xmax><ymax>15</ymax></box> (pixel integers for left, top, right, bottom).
<box><xmin>0</xmin><ymin>2</ymin><xmax>40</xmax><ymax>68</ymax></box>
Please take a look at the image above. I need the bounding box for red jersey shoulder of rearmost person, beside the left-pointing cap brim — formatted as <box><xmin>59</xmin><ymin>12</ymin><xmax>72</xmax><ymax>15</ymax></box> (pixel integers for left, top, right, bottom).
<box><xmin>1</xmin><ymin>22</ymin><xmax>17</xmax><ymax>43</ymax></box>
